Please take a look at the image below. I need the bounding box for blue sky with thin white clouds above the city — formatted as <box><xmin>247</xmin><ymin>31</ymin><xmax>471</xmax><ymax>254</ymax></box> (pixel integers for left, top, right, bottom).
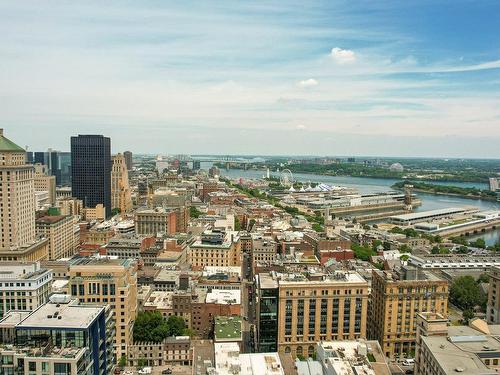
<box><xmin>0</xmin><ymin>0</ymin><xmax>500</xmax><ymax>158</ymax></box>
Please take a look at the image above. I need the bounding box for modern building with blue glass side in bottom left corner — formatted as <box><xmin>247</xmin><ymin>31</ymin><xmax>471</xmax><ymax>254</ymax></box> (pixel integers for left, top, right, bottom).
<box><xmin>0</xmin><ymin>295</ymin><xmax>115</xmax><ymax>375</ymax></box>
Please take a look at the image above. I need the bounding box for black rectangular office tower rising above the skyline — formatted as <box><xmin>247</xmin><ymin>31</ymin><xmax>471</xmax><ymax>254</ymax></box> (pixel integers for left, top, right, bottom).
<box><xmin>71</xmin><ymin>135</ymin><xmax>111</xmax><ymax>216</ymax></box>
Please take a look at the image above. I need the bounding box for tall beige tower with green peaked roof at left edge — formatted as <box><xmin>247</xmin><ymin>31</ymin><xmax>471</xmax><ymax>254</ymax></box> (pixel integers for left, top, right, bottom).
<box><xmin>0</xmin><ymin>129</ymin><xmax>35</xmax><ymax>250</ymax></box>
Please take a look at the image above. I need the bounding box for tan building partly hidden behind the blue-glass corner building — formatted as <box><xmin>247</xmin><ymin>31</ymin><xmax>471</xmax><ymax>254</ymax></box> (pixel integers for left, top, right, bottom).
<box><xmin>68</xmin><ymin>258</ymin><xmax>137</xmax><ymax>358</ymax></box>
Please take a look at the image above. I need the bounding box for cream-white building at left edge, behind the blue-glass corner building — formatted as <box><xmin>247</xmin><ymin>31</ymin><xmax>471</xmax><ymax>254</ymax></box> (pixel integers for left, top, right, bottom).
<box><xmin>0</xmin><ymin>262</ymin><xmax>52</xmax><ymax>317</ymax></box>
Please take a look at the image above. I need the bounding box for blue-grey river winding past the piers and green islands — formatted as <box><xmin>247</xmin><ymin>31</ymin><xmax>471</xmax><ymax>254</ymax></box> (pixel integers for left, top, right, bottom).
<box><xmin>203</xmin><ymin>166</ymin><xmax>500</xmax><ymax>245</ymax></box>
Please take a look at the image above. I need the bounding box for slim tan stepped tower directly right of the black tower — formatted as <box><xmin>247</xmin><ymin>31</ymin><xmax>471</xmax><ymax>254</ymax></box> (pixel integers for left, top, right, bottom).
<box><xmin>111</xmin><ymin>154</ymin><xmax>132</xmax><ymax>213</ymax></box>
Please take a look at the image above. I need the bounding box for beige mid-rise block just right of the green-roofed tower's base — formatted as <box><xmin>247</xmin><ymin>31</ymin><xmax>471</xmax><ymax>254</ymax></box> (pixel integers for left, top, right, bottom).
<box><xmin>36</xmin><ymin>215</ymin><xmax>80</xmax><ymax>260</ymax></box>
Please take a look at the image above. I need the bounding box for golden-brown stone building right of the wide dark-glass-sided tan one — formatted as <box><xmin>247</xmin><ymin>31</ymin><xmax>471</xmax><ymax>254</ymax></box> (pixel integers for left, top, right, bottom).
<box><xmin>369</xmin><ymin>268</ymin><xmax>448</xmax><ymax>358</ymax></box>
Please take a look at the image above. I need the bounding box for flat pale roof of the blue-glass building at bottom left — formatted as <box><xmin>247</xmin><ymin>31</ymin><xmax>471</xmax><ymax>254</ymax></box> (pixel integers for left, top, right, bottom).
<box><xmin>17</xmin><ymin>302</ymin><xmax>104</xmax><ymax>329</ymax></box>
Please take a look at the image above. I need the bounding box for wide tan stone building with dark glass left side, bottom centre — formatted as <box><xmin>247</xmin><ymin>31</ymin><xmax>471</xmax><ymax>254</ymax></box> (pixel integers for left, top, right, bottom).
<box><xmin>257</xmin><ymin>271</ymin><xmax>368</xmax><ymax>357</ymax></box>
